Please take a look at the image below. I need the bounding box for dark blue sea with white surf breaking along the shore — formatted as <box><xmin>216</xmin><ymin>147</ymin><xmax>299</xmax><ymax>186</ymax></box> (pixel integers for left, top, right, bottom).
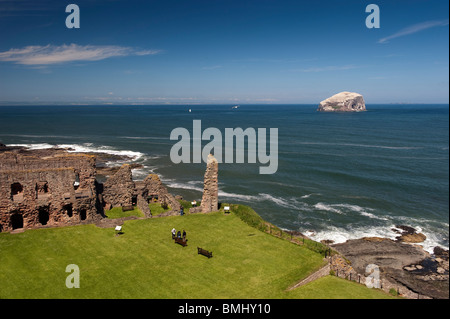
<box><xmin>0</xmin><ymin>104</ymin><xmax>449</xmax><ymax>252</ymax></box>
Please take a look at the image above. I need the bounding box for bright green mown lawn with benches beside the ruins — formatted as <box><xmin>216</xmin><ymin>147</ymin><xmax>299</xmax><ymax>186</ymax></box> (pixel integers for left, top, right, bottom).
<box><xmin>0</xmin><ymin>212</ymin><xmax>394</xmax><ymax>299</ymax></box>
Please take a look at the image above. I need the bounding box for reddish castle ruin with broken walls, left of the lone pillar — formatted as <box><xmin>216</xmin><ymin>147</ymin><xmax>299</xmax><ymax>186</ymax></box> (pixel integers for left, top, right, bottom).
<box><xmin>0</xmin><ymin>149</ymin><xmax>181</xmax><ymax>232</ymax></box>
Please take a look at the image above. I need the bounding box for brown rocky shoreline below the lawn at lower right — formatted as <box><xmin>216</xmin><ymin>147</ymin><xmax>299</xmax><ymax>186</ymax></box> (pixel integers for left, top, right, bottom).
<box><xmin>329</xmin><ymin>225</ymin><xmax>449</xmax><ymax>299</ymax></box>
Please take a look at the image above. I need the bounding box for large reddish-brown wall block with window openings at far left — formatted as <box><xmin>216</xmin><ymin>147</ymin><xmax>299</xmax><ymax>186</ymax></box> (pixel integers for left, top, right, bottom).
<box><xmin>0</xmin><ymin>152</ymin><xmax>102</xmax><ymax>231</ymax></box>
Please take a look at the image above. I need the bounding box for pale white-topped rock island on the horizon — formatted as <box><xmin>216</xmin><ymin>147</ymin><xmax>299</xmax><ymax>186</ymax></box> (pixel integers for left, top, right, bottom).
<box><xmin>317</xmin><ymin>92</ymin><xmax>366</xmax><ymax>112</ymax></box>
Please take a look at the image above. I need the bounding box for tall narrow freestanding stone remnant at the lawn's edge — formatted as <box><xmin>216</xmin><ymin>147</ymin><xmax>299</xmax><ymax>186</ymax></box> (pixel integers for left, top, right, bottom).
<box><xmin>200</xmin><ymin>154</ymin><xmax>219</xmax><ymax>213</ymax></box>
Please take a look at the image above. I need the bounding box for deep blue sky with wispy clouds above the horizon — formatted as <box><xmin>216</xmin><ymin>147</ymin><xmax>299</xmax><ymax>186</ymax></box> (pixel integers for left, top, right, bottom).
<box><xmin>0</xmin><ymin>0</ymin><xmax>449</xmax><ymax>104</ymax></box>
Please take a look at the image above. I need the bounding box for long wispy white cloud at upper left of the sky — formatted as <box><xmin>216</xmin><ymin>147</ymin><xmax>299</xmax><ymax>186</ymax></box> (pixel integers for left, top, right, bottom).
<box><xmin>0</xmin><ymin>43</ymin><xmax>161</xmax><ymax>66</ymax></box>
